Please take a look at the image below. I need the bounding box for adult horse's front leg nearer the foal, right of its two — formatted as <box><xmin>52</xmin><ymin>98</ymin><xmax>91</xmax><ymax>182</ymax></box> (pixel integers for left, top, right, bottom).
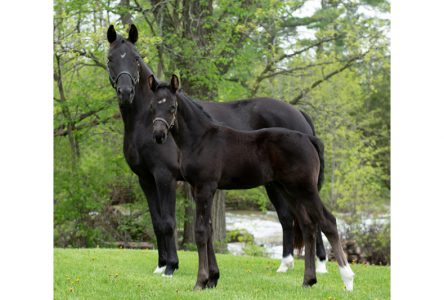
<box><xmin>154</xmin><ymin>168</ymin><xmax>179</xmax><ymax>277</ymax></box>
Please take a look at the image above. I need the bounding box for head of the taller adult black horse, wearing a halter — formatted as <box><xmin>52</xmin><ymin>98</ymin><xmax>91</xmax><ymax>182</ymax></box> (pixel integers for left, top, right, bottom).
<box><xmin>107</xmin><ymin>24</ymin><xmax>140</xmax><ymax>105</ymax></box>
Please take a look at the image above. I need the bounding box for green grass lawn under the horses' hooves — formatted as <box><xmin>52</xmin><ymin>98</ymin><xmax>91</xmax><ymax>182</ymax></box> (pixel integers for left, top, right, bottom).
<box><xmin>54</xmin><ymin>249</ymin><xmax>390</xmax><ymax>299</ymax></box>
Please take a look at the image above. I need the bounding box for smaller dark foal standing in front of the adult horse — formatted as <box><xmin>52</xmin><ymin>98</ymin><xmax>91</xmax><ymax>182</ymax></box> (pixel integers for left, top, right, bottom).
<box><xmin>148</xmin><ymin>75</ymin><xmax>354</xmax><ymax>290</ymax></box>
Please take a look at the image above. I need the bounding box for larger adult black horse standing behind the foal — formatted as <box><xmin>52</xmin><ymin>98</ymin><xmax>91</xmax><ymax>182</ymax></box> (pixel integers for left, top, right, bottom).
<box><xmin>107</xmin><ymin>25</ymin><xmax>326</xmax><ymax>275</ymax></box>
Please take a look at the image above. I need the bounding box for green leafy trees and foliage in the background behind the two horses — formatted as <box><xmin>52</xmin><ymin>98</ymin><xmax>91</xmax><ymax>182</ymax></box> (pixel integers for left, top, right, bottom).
<box><xmin>54</xmin><ymin>0</ymin><xmax>390</xmax><ymax>246</ymax></box>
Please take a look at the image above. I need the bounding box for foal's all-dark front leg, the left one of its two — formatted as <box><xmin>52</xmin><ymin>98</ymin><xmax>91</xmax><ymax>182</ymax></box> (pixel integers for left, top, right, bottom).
<box><xmin>193</xmin><ymin>184</ymin><xmax>216</xmax><ymax>290</ymax></box>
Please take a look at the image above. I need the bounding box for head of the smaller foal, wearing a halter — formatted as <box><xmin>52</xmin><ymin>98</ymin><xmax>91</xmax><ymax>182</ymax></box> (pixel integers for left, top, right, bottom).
<box><xmin>148</xmin><ymin>75</ymin><xmax>179</xmax><ymax>144</ymax></box>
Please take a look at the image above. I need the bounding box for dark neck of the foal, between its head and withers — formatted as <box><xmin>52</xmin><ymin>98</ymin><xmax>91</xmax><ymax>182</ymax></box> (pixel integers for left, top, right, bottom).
<box><xmin>173</xmin><ymin>97</ymin><xmax>217</xmax><ymax>152</ymax></box>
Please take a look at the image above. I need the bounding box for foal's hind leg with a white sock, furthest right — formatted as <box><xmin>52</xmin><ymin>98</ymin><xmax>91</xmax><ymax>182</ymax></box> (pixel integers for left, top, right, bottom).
<box><xmin>320</xmin><ymin>207</ymin><xmax>355</xmax><ymax>291</ymax></box>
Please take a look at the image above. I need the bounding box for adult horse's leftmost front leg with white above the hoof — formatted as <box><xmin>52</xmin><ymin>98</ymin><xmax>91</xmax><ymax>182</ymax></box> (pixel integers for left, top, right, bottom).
<box><xmin>139</xmin><ymin>175</ymin><xmax>167</xmax><ymax>274</ymax></box>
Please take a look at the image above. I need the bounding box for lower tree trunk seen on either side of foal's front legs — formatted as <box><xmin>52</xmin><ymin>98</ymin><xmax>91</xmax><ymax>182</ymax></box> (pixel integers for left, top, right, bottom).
<box><xmin>182</xmin><ymin>183</ymin><xmax>227</xmax><ymax>252</ymax></box>
